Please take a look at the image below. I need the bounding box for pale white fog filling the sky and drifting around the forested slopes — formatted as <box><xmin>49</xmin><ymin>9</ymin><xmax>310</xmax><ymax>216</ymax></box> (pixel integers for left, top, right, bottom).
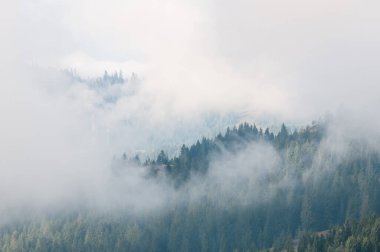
<box><xmin>0</xmin><ymin>0</ymin><xmax>380</xmax><ymax>217</ymax></box>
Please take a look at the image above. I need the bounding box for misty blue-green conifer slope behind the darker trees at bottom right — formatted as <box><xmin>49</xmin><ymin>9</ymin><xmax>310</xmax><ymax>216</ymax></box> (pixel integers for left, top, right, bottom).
<box><xmin>0</xmin><ymin>123</ymin><xmax>380</xmax><ymax>251</ymax></box>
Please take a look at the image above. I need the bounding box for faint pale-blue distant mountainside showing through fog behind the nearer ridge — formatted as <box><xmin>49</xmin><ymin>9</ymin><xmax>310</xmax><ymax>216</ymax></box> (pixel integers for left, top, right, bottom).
<box><xmin>64</xmin><ymin>70</ymin><xmax>278</xmax><ymax>159</ymax></box>
